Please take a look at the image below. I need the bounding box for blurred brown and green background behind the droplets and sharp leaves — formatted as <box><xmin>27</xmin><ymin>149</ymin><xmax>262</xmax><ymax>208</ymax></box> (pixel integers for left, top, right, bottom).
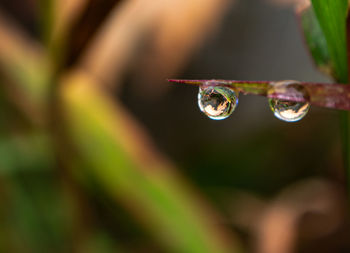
<box><xmin>0</xmin><ymin>0</ymin><xmax>350</xmax><ymax>253</ymax></box>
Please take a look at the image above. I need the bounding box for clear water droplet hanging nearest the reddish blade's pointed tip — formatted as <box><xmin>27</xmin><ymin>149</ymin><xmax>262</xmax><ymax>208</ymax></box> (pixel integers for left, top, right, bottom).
<box><xmin>198</xmin><ymin>86</ymin><xmax>238</xmax><ymax>120</ymax></box>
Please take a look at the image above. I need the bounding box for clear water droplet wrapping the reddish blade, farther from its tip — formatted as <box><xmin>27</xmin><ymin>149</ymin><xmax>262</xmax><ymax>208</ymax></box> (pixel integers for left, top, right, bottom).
<box><xmin>268</xmin><ymin>81</ymin><xmax>310</xmax><ymax>122</ymax></box>
